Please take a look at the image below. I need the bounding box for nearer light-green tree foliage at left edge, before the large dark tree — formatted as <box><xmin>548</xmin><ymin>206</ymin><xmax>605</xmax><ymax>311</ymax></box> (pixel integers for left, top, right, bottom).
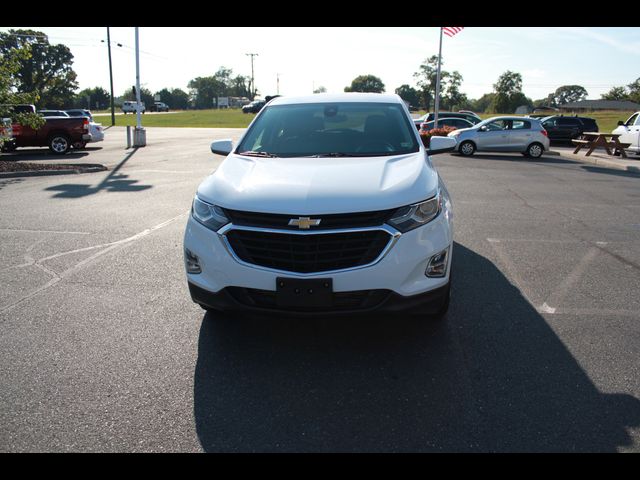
<box><xmin>0</xmin><ymin>41</ymin><xmax>45</xmax><ymax>147</ymax></box>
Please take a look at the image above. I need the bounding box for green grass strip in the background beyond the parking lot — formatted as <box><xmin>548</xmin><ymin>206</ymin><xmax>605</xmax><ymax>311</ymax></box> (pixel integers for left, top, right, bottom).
<box><xmin>93</xmin><ymin>109</ymin><xmax>633</xmax><ymax>132</ymax></box>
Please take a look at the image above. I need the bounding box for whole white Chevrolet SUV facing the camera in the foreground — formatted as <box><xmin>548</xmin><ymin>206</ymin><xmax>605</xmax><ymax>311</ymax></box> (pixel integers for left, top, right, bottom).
<box><xmin>184</xmin><ymin>93</ymin><xmax>455</xmax><ymax>317</ymax></box>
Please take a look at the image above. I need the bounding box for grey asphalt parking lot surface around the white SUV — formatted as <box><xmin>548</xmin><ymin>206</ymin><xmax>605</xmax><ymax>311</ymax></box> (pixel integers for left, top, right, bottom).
<box><xmin>0</xmin><ymin>128</ymin><xmax>640</xmax><ymax>452</ymax></box>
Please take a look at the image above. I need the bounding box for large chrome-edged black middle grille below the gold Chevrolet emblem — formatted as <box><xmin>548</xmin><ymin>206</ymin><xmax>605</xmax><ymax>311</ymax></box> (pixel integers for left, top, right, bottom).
<box><xmin>226</xmin><ymin>230</ymin><xmax>390</xmax><ymax>273</ymax></box>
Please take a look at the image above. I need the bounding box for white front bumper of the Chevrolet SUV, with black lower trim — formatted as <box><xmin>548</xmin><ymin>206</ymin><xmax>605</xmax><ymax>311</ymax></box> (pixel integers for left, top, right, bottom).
<box><xmin>184</xmin><ymin>209</ymin><xmax>453</xmax><ymax>312</ymax></box>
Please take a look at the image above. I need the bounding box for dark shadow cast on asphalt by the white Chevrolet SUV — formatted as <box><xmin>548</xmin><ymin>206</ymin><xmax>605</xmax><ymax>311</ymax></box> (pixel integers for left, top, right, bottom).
<box><xmin>194</xmin><ymin>243</ymin><xmax>640</xmax><ymax>452</ymax></box>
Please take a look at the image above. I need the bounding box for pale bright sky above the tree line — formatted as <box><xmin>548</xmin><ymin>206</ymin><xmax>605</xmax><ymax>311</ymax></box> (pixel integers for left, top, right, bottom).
<box><xmin>0</xmin><ymin>26</ymin><xmax>640</xmax><ymax>100</ymax></box>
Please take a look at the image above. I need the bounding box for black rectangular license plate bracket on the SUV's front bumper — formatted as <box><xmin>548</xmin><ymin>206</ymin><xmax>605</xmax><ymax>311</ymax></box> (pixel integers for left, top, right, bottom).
<box><xmin>276</xmin><ymin>277</ymin><xmax>333</xmax><ymax>308</ymax></box>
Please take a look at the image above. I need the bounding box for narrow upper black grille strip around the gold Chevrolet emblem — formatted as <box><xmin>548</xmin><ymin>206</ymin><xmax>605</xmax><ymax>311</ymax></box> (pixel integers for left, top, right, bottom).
<box><xmin>224</xmin><ymin>208</ymin><xmax>395</xmax><ymax>230</ymax></box>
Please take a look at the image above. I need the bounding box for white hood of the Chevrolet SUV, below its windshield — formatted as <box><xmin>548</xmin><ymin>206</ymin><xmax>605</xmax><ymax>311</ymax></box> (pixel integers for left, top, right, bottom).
<box><xmin>198</xmin><ymin>151</ymin><xmax>438</xmax><ymax>215</ymax></box>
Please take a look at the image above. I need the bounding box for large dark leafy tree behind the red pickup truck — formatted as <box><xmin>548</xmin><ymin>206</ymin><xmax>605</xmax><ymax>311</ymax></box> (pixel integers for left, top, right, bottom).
<box><xmin>0</xmin><ymin>30</ymin><xmax>78</xmax><ymax>108</ymax></box>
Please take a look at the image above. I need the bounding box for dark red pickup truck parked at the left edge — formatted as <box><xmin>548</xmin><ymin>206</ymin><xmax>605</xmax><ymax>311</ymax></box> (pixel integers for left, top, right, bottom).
<box><xmin>2</xmin><ymin>117</ymin><xmax>91</xmax><ymax>155</ymax></box>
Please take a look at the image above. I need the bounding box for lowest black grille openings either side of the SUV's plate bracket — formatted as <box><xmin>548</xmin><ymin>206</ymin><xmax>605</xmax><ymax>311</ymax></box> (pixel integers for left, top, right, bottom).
<box><xmin>226</xmin><ymin>287</ymin><xmax>391</xmax><ymax>312</ymax></box>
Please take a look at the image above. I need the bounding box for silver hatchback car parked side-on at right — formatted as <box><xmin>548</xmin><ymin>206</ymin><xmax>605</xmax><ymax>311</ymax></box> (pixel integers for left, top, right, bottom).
<box><xmin>448</xmin><ymin>117</ymin><xmax>550</xmax><ymax>158</ymax></box>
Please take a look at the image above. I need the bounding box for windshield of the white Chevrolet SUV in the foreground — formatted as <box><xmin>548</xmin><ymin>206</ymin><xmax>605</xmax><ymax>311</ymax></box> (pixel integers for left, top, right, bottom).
<box><xmin>236</xmin><ymin>102</ymin><xmax>419</xmax><ymax>157</ymax></box>
